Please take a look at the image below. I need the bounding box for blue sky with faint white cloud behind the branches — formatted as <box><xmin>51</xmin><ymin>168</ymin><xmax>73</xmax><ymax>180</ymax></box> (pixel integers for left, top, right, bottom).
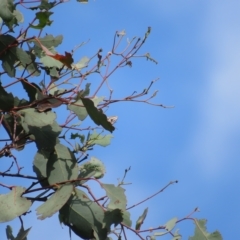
<box><xmin>0</xmin><ymin>0</ymin><xmax>240</xmax><ymax>240</ymax></box>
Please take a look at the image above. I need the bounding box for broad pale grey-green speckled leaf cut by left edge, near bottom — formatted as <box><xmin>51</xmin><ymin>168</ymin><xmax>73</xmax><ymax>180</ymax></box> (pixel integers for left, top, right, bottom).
<box><xmin>0</xmin><ymin>187</ymin><xmax>32</xmax><ymax>222</ymax></box>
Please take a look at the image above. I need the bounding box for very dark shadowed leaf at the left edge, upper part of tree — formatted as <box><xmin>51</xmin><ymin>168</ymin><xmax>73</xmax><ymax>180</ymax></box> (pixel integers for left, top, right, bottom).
<box><xmin>0</xmin><ymin>34</ymin><xmax>18</xmax><ymax>77</ymax></box>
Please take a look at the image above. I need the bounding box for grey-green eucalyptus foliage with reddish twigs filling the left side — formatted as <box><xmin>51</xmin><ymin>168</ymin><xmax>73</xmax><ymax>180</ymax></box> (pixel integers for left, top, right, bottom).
<box><xmin>0</xmin><ymin>0</ymin><xmax>222</xmax><ymax>240</ymax></box>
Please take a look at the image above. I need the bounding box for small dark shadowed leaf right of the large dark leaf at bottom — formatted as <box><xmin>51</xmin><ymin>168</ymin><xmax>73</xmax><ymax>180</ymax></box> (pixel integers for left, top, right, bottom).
<box><xmin>103</xmin><ymin>209</ymin><xmax>123</xmax><ymax>232</ymax></box>
